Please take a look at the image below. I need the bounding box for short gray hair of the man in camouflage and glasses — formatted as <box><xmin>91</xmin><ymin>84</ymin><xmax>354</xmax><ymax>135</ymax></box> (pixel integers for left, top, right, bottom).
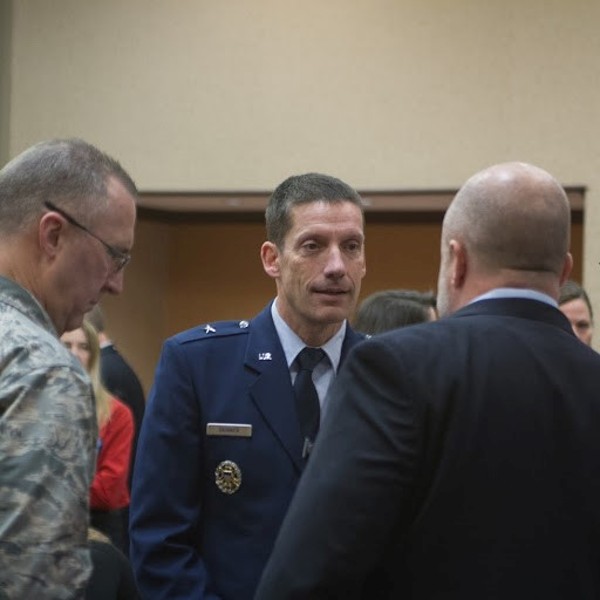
<box><xmin>0</xmin><ymin>138</ymin><xmax>137</xmax><ymax>234</ymax></box>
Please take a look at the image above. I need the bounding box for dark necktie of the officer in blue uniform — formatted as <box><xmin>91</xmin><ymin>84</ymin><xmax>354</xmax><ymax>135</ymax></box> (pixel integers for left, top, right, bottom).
<box><xmin>294</xmin><ymin>346</ymin><xmax>325</xmax><ymax>458</ymax></box>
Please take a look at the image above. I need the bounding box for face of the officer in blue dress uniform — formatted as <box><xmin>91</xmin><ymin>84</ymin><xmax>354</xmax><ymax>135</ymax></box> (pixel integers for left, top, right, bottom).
<box><xmin>262</xmin><ymin>201</ymin><xmax>366</xmax><ymax>341</ymax></box>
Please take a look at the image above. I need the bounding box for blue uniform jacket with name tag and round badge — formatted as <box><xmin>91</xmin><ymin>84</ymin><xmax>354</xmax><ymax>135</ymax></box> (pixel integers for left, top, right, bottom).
<box><xmin>130</xmin><ymin>306</ymin><xmax>363</xmax><ymax>600</ymax></box>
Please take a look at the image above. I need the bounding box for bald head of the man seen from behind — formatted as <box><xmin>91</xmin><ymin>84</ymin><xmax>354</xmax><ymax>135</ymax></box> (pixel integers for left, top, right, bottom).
<box><xmin>439</xmin><ymin>162</ymin><xmax>571</xmax><ymax>313</ymax></box>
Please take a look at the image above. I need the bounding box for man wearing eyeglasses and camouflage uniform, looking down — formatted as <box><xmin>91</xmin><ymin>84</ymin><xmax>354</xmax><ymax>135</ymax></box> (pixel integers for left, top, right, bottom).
<box><xmin>0</xmin><ymin>140</ymin><xmax>137</xmax><ymax>598</ymax></box>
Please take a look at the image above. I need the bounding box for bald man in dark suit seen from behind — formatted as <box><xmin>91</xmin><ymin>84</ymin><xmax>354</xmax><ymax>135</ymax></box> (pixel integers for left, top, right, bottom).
<box><xmin>256</xmin><ymin>163</ymin><xmax>600</xmax><ymax>600</ymax></box>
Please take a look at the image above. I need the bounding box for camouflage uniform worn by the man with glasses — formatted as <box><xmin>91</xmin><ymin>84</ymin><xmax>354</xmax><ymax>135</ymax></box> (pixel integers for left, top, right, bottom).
<box><xmin>0</xmin><ymin>277</ymin><xmax>97</xmax><ymax>600</ymax></box>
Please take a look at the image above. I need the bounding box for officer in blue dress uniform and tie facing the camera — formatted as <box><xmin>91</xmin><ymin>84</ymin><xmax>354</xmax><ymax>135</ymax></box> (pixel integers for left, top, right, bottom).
<box><xmin>130</xmin><ymin>173</ymin><xmax>365</xmax><ymax>600</ymax></box>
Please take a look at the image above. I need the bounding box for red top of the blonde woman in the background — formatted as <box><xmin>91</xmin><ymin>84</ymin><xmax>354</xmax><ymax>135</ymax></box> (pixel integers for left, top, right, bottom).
<box><xmin>90</xmin><ymin>398</ymin><xmax>133</xmax><ymax>510</ymax></box>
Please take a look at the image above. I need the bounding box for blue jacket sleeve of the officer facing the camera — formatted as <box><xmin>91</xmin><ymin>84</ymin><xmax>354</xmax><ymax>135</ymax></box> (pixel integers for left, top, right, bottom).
<box><xmin>130</xmin><ymin>341</ymin><xmax>223</xmax><ymax>600</ymax></box>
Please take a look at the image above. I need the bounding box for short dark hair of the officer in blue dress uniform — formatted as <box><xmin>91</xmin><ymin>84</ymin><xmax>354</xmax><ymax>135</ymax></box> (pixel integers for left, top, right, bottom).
<box><xmin>265</xmin><ymin>173</ymin><xmax>364</xmax><ymax>248</ymax></box>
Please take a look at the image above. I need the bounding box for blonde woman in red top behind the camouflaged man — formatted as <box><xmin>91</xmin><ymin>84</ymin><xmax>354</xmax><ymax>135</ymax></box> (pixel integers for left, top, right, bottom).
<box><xmin>61</xmin><ymin>321</ymin><xmax>134</xmax><ymax>550</ymax></box>
